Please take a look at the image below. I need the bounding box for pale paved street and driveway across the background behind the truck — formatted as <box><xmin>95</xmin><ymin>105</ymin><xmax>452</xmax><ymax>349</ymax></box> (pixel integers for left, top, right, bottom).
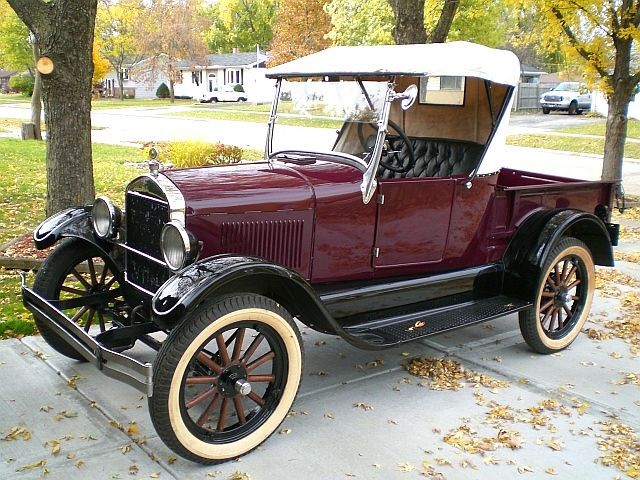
<box><xmin>0</xmin><ymin>104</ymin><xmax>640</xmax><ymax>195</ymax></box>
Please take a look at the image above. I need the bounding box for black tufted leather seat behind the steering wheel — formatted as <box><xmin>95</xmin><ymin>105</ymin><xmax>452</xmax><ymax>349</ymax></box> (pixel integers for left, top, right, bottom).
<box><xmin>378</xmin><ymin>137</ymin><xmax>484</xmax><ymax>178</ymax></box>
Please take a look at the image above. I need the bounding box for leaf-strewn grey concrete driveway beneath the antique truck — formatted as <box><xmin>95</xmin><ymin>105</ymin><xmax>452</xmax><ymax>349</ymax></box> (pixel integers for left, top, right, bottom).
<box><xmin>0</xmin><ymin>241</ymin><xmax>640</xmax><ymax>480</ymax></box>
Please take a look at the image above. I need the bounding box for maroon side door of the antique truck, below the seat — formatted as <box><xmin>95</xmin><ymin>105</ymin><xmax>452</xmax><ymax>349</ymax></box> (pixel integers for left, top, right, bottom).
<box><xmin>373</xmin><ymin>178</ymin><xmax>455</xmax><ymax>271</ymax></box>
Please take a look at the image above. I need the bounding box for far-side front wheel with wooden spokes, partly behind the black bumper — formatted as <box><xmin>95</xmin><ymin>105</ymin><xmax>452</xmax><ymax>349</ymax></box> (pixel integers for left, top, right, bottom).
<box><xmin>33</xmin><ymin>238</ymin><xmax>121</xmax><ymax>360</ymax></box>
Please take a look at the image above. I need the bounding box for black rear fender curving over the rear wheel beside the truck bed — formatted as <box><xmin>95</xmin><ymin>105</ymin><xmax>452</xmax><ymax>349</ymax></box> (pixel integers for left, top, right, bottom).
<box><xmin>503</xmin><ymin>210</ymin><xmax>614</xmax><ymax>298</ymax></box>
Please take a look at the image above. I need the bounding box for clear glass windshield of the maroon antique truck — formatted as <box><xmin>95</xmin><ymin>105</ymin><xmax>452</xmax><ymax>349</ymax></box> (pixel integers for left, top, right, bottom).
<box><xmin>271</xmin><ymin>79</ymin><xmax>388</xmax><ymax>158</ymax></box>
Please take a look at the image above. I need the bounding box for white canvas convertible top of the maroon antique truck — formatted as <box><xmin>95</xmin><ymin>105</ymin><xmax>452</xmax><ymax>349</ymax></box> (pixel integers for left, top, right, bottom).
<box><xmin>266</xmin><ymin>42</ymin><xmax>520</xmax><ymax>86</ymax></box>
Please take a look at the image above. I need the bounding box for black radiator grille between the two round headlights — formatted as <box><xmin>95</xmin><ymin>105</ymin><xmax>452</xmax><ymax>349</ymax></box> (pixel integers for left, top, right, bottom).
<box><xmin>125</xmin><ymin>192</ymin><xmax>170</xmax><ymax>292</ymax></box>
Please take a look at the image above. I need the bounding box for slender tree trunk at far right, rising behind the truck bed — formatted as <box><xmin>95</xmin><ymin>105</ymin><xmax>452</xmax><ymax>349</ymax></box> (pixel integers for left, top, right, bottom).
<box><xmin>602</xmin><ymin>89</ymin><xmax>630</xmax><ymax>181</ymax></box>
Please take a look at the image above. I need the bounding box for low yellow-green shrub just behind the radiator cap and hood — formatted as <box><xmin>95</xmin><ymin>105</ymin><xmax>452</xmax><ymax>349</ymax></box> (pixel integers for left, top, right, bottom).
<box><xmin>166</xmin><ymin>140</ymin><xmax>242</xmax><ymax>168</ymax></box>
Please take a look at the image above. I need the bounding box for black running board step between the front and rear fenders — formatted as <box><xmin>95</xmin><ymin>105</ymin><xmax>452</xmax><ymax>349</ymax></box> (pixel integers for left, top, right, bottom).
<box><xmin>344</xmin><ymin>295</ymin><xmax>532</xmax><ymax>347</ymax></box>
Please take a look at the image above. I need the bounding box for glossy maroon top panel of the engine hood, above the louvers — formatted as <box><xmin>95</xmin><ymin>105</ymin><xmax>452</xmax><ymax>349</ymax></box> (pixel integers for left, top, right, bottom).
<box><xmin>163</xmin><ymin>162</ymin><xmax>315</xmax><ymax>215</ymax></box>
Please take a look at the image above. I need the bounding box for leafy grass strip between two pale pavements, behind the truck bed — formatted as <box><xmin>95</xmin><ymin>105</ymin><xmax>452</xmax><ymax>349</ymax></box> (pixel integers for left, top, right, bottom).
<box><xmin>507</xmin><ymin>134</ymin><xmax>640</xmax><ymax>159</ymax></box>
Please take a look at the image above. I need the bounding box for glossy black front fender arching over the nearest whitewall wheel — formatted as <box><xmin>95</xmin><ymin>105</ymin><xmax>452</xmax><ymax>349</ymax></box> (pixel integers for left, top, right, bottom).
<box><xmin>152</xmin><ymin>255</ymin><xmax>340</xmax><ymax>333</ymax></box>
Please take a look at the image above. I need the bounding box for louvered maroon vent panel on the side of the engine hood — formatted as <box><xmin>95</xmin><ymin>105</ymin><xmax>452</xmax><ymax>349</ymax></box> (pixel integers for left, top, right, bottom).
<box><xmin>221</xmin><ymin>220</ymin><xmax>304</xmax><ymax>268</ymax></box>
